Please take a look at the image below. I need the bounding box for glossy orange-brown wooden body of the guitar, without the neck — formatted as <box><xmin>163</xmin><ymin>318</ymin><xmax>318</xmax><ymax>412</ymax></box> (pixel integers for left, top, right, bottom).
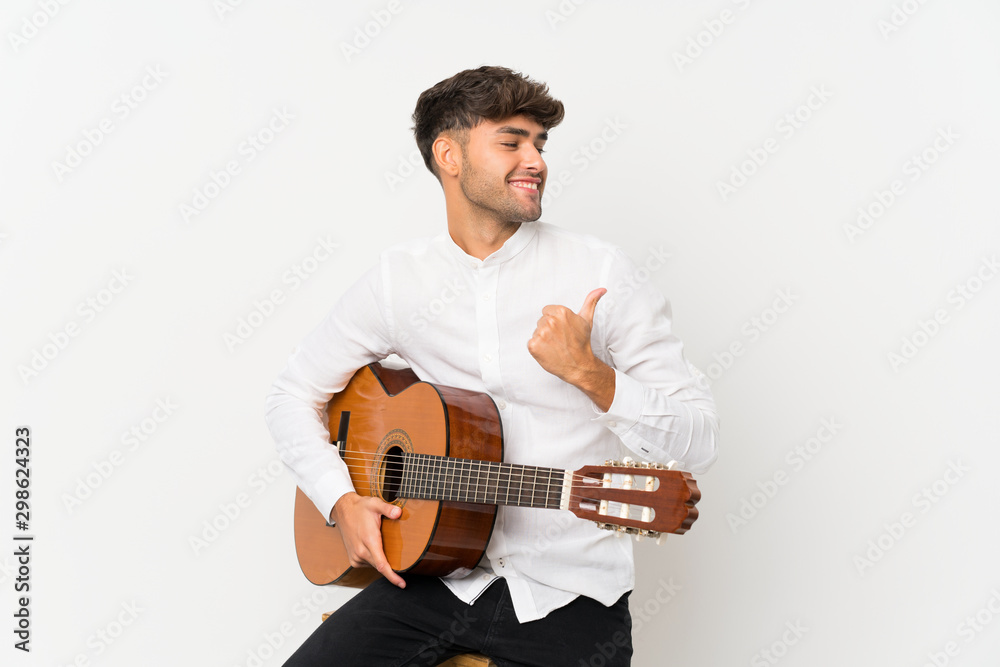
<box><xmin>295</xmin><ymin>363</ymin><xmax>503</xmax><ymax>588</ymax></box>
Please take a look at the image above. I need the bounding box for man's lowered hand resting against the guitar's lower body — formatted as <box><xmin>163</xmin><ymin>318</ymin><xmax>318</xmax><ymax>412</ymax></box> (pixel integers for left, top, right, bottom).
<box><xmin>330</xmin><ymin>492</ymin><xmax>406</xmax><ymax>588</ymax></box>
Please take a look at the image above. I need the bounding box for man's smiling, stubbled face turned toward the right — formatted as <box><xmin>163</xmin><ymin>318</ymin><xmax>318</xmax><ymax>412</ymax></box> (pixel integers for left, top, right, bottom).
<box><xmin>459</xmin><ymin>116</ymin><xmax>548</xmax><ymax>223</ymax></box>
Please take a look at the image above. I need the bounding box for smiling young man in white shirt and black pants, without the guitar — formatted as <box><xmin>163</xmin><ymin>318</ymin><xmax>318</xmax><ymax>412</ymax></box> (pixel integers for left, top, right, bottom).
<box><xmin>267</xmin><ymin>67</ymin><xmax>718</xmax><ymax>667</ymax></box>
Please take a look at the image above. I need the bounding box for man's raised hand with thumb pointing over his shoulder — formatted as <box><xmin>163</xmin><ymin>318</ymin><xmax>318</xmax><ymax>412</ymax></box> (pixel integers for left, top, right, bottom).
<box><xmin>528</xmin><ymin>287</ymin><xmax>615</xmax><ymax>412</ymax></box>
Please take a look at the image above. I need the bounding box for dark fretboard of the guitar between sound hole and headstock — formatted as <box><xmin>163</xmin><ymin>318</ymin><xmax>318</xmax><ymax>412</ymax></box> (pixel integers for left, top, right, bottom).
<box><xmin>399</xmin><ymin>453</ymin><xmax>566</xmax><ymax>509</ymax></box>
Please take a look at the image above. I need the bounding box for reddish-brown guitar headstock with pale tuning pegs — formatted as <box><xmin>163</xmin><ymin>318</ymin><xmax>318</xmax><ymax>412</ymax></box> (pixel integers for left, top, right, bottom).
<box><xmin>565</xmin><ymin>458</ymin><xmax>701</xmax><ymax>538</ymax></box>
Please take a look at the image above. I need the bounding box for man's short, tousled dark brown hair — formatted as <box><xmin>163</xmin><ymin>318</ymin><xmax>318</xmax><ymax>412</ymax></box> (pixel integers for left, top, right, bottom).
<box><xmin>413</xmin><ymin>65</ymin><xmax>563</xmax><ymax>180</ymax></box>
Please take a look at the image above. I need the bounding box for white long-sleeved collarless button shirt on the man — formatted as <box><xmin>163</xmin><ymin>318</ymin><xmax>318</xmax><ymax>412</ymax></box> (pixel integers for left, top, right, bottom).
<box><xmin>267</xmin><ymin>223</ymin><xmax>718</xmax><ymax>623</ymax></box>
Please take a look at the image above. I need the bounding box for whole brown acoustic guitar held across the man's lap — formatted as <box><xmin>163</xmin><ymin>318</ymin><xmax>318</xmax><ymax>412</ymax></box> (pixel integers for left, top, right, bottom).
<box><xmin>295</xmin><ymin>363</ymin><xmax>701</xmax><ymax>587</ymax></box>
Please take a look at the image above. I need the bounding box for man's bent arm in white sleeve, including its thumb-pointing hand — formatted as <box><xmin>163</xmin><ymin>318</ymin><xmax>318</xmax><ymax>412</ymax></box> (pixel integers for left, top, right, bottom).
<box><xmin>528</xmin><ymin>251</ymin><xmax>719</xmax><ymax>473</ymax></box>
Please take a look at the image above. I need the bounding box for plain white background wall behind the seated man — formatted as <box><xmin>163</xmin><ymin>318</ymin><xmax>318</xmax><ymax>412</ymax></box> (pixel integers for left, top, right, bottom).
<box><xmin>0</xmin><ymin>0</ymin><xmax>1000</xmax><ymax>667</ymax></box>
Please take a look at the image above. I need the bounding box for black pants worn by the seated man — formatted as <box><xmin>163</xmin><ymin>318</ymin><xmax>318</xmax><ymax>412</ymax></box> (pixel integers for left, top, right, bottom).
<box><xmin>285</xmin><ymin>575</ymin><xmax>632</xmax><ymax>667</ymax></box>
